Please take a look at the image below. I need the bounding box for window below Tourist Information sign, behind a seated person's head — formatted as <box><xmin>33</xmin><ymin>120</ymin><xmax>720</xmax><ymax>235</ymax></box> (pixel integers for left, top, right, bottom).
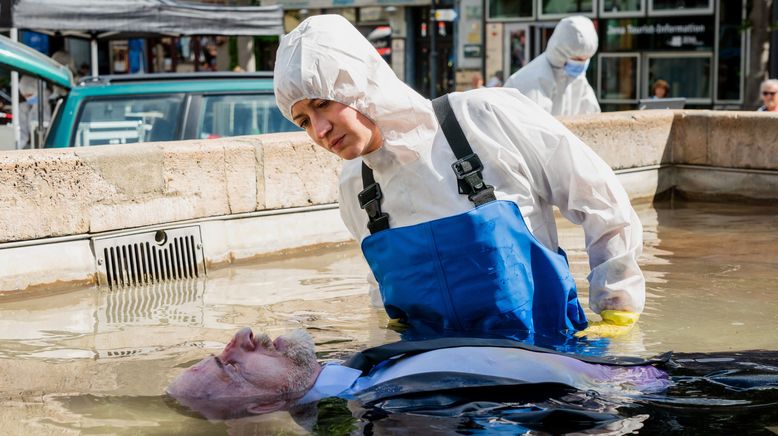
<box><xmin>645</xmin><ymin>52</ymin><xmax>711</xmax><ymax>103</ymax></box>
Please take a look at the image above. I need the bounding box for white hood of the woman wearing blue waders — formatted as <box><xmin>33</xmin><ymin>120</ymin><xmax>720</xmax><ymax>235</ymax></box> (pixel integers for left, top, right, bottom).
<box><xmin>273</xmin><ymin>15</ymin><xmax>438</xmax><ymax>162</ymax></box>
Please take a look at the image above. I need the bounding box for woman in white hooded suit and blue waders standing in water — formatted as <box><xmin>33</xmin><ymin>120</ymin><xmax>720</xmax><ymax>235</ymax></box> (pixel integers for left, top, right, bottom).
<box><xmin>274</xmin><ymin>15</ymin><xmax>645</xmax><ymax>333</ymax></box>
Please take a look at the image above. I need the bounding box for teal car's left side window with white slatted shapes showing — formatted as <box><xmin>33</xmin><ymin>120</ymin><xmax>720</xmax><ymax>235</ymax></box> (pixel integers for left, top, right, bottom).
<box><xmin>73</xmin><ymin>94</ymin><xmax>184</xmax><ymax>147</ymax></box>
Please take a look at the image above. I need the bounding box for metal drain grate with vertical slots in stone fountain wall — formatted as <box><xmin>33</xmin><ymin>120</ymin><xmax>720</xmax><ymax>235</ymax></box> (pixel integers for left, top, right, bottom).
<box><xmin>92</xmin><ymin>226</ymin><xmax>205</xmax><ymax>288</ymax></box>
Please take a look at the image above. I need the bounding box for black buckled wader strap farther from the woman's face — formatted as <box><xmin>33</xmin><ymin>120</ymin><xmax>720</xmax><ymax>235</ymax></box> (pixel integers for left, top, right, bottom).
<box><xmin>432</xmin><ymin>94</ymin><xmax>496</xmax><ymax>206</ymax></box>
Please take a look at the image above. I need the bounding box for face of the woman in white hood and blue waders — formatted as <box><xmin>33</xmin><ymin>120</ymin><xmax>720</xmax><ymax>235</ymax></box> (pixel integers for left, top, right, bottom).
<box><xmin>292</xmin><ymin>98</ymin><xmax>383</xmax><ymax>160</ymax></box>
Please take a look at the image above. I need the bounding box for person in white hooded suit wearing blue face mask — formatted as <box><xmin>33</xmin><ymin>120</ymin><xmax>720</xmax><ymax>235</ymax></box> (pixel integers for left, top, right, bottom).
<box><xmin>504</xmin><ymin>16</ymin><xmax>600</xmax><ymax>116</ymax></box>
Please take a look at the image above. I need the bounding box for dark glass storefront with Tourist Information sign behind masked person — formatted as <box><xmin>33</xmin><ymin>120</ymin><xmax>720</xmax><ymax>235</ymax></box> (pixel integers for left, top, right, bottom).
<box><xmin>484</xmin><ymin>0</ymin><xmax>749</xmax><ymax>110</ymax></box>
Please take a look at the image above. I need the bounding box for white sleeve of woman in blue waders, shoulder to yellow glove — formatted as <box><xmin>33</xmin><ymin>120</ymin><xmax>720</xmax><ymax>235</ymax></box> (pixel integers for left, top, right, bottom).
<box><xmin>471</xmin><ymin>93</ymin><xmax>645</xmax><ymax>313</ymax></box>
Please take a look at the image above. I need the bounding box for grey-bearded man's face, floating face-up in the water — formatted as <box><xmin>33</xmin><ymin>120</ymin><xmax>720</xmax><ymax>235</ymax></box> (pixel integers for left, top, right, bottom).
<box><xmin>167</xmin><ymin>327</ymin><xmax>320</xmax><ymax>418</ymax></box>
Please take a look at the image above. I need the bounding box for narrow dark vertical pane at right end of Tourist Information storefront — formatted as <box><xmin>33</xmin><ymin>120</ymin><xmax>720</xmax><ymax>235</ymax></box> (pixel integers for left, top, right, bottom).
<box><xmin>716</xmin><ymin>1</ymin><xmax>745</xmax><ymax>103</ymax></box>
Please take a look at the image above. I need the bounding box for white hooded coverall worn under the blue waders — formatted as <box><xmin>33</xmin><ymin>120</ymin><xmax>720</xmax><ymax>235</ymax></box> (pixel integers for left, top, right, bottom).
<box><xmin>274</xmin><ymin>15</ymin><xmax>645</xmax><ymax>313</ymax></box>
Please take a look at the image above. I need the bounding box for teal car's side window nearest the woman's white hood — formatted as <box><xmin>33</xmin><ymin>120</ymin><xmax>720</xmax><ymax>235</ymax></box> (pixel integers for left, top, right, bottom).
<box><xmin>195</xmin><ymin>94</ymin><xmax>300</xmax><ymax>139</ymax></box>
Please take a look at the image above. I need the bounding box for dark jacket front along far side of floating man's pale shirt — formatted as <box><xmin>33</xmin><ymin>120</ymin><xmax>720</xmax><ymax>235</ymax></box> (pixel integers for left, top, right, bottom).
<box><xmin>343</xmin><ymin>337</ymin><xmax>672</xmax><ymax>375</ymax></box>
